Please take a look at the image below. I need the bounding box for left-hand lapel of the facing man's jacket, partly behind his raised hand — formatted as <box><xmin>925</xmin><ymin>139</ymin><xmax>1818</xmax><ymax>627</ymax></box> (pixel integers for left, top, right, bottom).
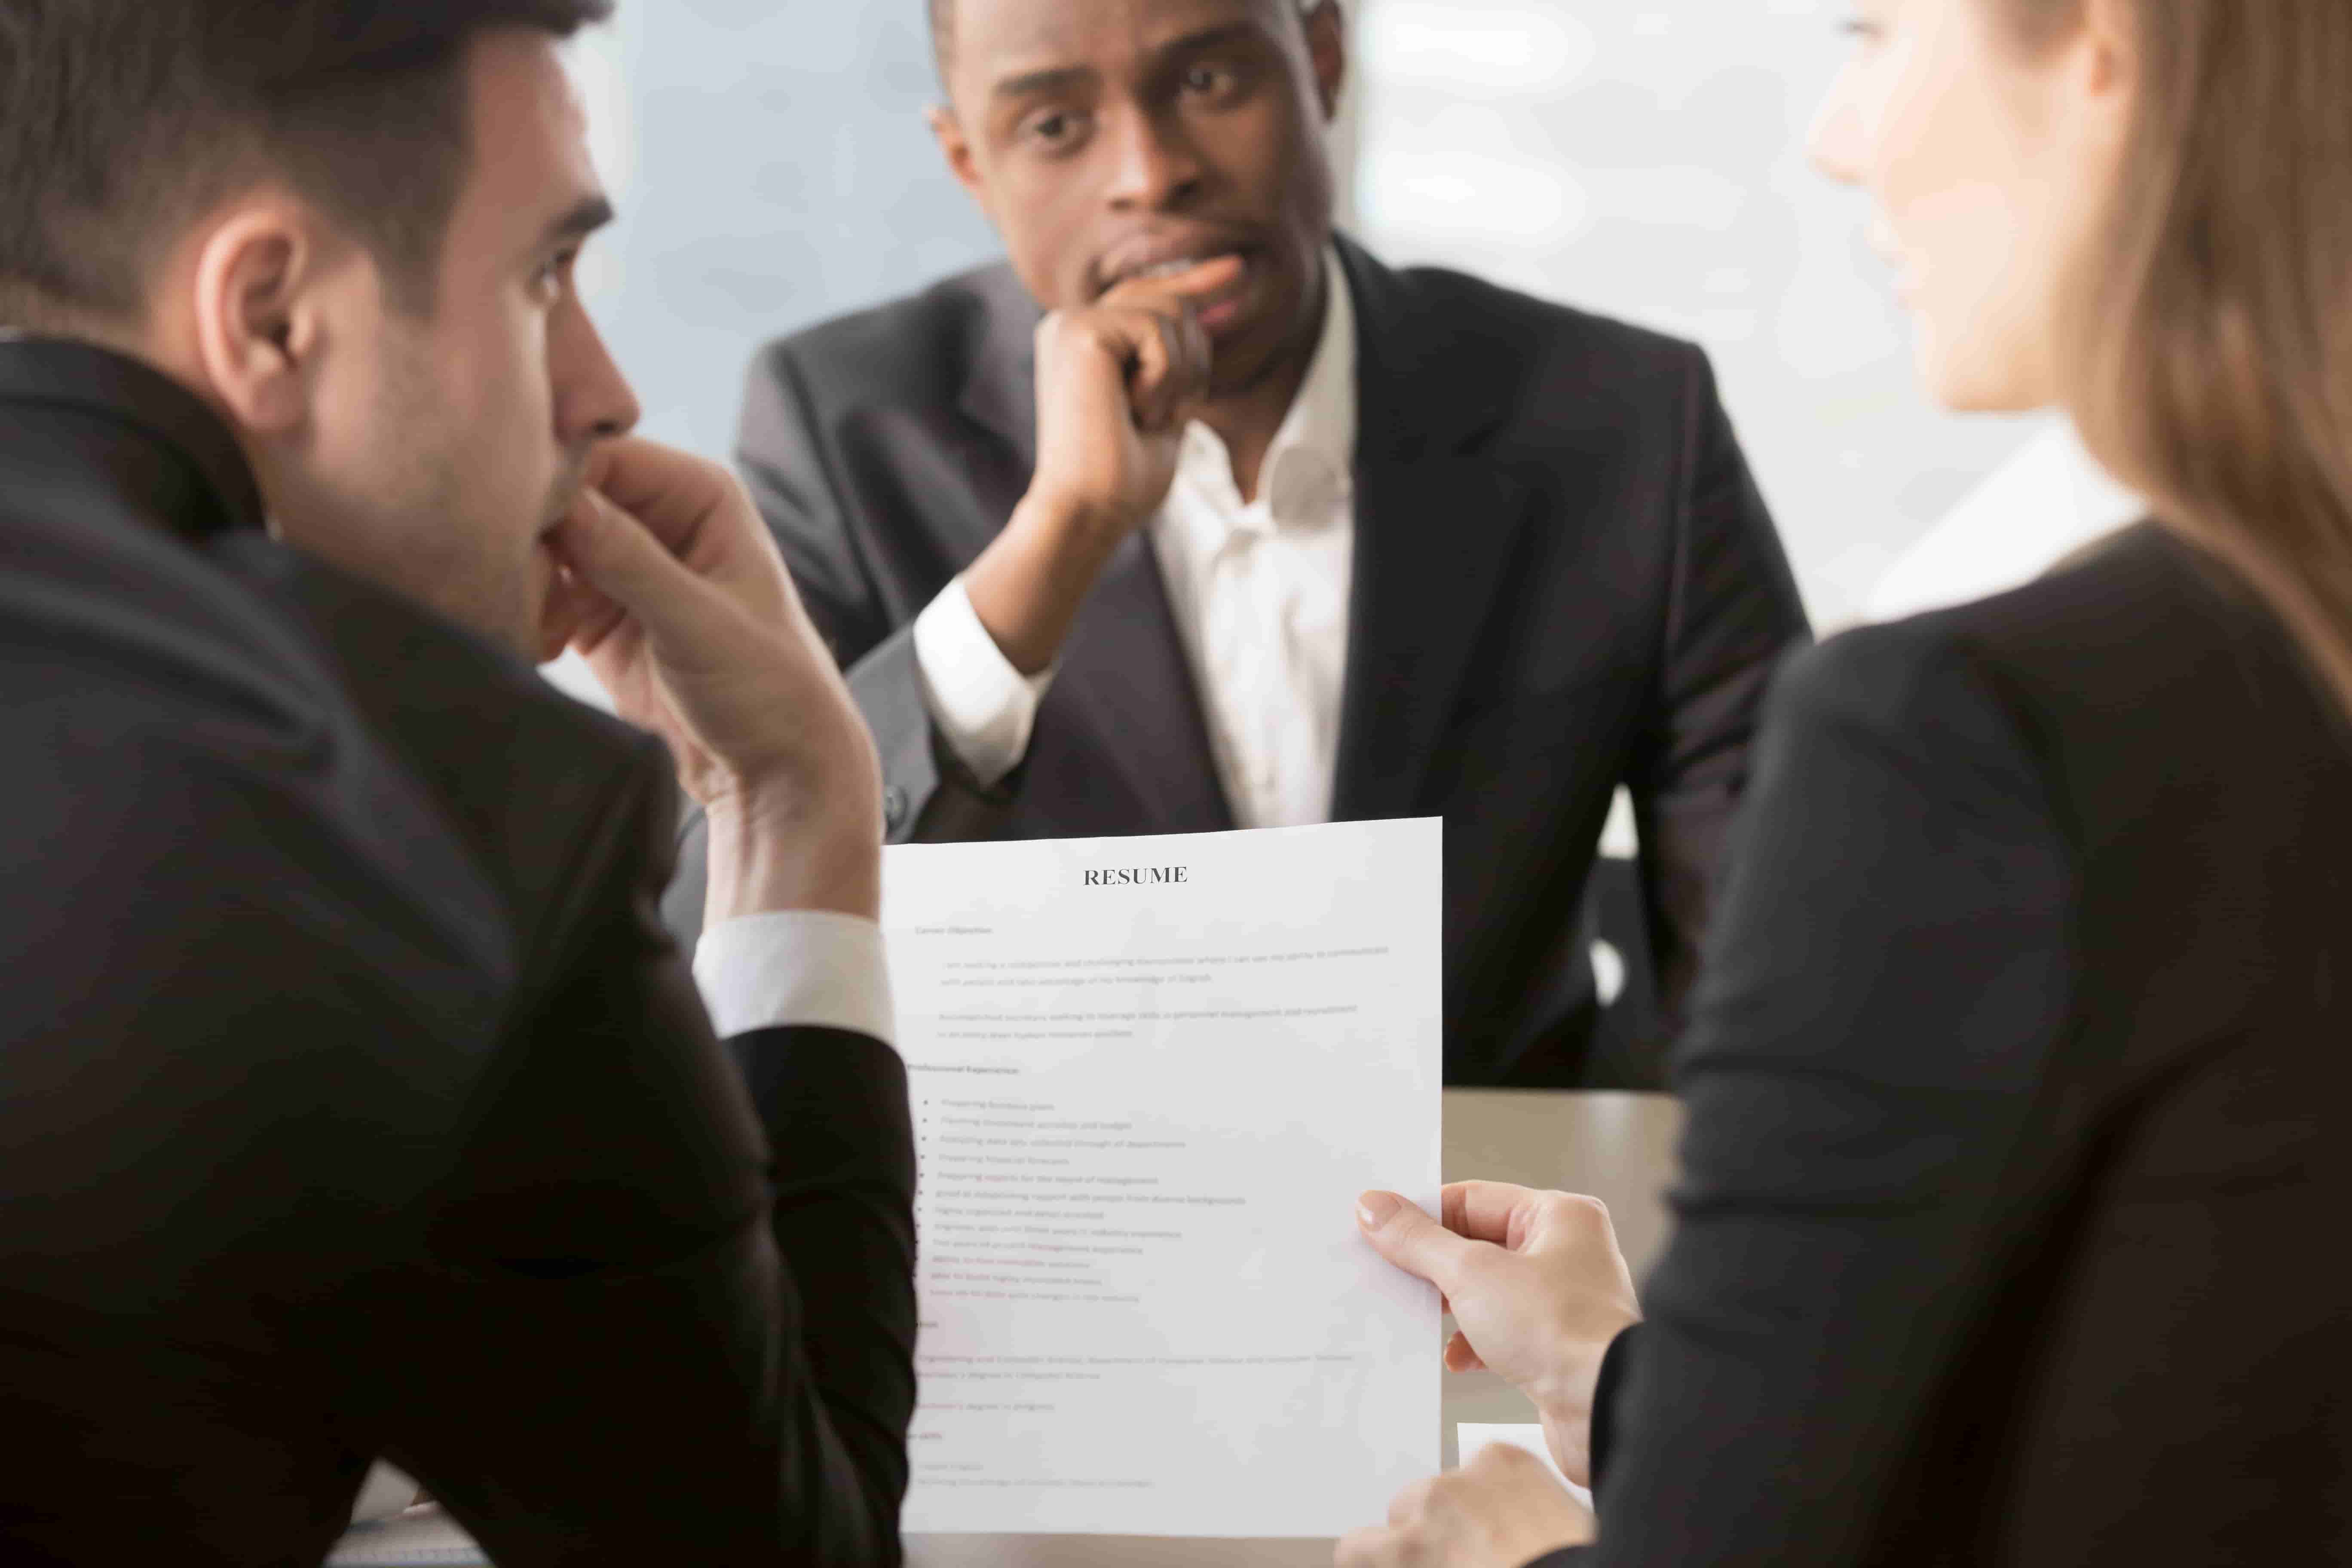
<box><xmin>960</xmin><ymin>268</ymin><xmax>1232</xmax><ymax>832</ymax></box>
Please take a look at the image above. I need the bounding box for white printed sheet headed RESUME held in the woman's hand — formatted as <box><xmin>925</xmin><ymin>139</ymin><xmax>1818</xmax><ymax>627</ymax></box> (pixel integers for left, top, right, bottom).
<box><xmin>882</xmin><ymin>821</ymin><xmax>1442</xmax><ymax>1537</ymax></box>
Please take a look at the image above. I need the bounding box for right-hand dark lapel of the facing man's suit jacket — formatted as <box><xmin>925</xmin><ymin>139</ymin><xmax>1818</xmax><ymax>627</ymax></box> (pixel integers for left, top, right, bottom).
<box><xmin>1331</xmin><ymin>240</ymin><xmax>1529</xmax><ymax>821</ymax></box>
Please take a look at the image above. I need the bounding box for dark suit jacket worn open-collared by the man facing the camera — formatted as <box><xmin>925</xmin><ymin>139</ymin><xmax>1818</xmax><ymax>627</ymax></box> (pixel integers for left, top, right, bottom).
<box><xmin>675</xmin><ymin>242</ymin><xmax>1806</xmax><ymax>1084</ymax></box>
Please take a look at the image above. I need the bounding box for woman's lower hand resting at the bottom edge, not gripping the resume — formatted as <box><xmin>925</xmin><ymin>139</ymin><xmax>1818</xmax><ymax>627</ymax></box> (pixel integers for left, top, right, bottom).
<box><xmin>1334</xmin><ymin>1443</ymin><xmax>1592</xmax><ymax>1568</ymax></box>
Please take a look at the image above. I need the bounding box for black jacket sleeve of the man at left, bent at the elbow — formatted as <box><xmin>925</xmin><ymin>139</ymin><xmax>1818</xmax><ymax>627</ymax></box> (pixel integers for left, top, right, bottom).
<box><xmin>386</xmin><ymin>764</ymin><xmax>915</xmax><ymax>1563</ymax></box>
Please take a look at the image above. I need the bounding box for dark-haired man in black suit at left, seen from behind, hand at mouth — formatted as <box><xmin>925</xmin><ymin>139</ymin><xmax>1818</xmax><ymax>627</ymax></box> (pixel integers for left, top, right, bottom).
<box><xmin>0</xmin><ymin>0</ymin><xmax>915</xmax><ymax>1568</ymax></box>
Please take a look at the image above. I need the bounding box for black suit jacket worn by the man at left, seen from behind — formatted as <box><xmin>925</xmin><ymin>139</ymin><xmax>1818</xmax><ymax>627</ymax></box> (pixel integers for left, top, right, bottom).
<box><xmin>0</xmin><ymin>341</ymin><xmax>915</xmax><ymax>1568</ymax></box>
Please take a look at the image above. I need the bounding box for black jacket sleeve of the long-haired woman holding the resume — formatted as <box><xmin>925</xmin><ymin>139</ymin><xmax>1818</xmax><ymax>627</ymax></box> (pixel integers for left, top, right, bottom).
<box><xmin>1557</xmin><ymin>630</ymin><xmax>2072</xmax><ymax>1568</ymax></box>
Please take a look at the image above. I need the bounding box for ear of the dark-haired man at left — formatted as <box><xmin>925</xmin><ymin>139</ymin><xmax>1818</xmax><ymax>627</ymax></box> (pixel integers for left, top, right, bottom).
<box><xmin>195</xmin><ymin>200</ymin><xmax>341</xmax><ymax>437</ymax></box>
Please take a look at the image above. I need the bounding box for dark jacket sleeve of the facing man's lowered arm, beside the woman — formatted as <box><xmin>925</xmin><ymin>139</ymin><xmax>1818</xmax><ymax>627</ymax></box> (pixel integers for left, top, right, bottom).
<box><xmin>1625</xmin><ymin>350</ymin><xmax>1811</xmax><ymax>1034</ymax></box>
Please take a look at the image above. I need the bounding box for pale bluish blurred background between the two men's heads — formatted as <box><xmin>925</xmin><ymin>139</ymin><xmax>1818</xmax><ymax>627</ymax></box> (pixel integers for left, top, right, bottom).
<box><xmin>574</xmin><ymin>10</ymin><xmax>995</xmax><ymax>456</ymax></box>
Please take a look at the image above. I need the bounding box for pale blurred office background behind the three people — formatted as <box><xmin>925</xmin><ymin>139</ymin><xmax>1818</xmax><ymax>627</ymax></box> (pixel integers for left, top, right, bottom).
<box><xmin>564</xmin><ymin>0</ymin><xmax>2128</xmax><ymax>628</ymax></box>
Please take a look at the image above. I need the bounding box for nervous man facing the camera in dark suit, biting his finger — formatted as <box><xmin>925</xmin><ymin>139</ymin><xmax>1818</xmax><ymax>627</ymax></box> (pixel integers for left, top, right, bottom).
<box><xmin>675</xmin><ymin>0</ymin><xmax>1806</xmax><ymax>1084</ymax></box>
